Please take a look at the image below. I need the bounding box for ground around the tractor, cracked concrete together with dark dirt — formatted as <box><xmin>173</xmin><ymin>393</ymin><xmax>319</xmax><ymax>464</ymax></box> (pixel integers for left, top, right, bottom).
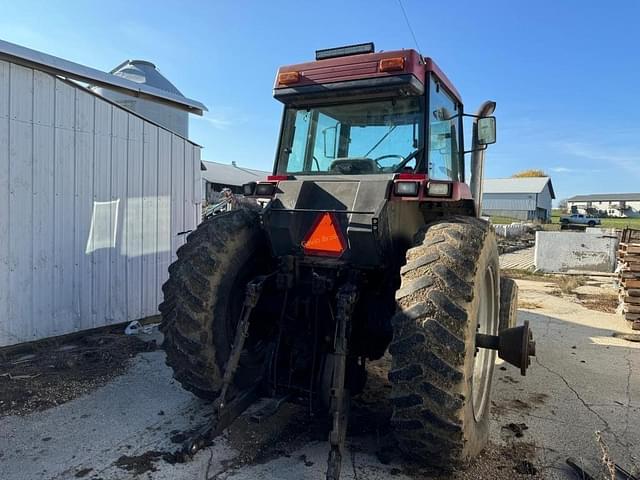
<box><xmin>0</xmin><ymin>277</ymin><xmax>640</xmax><ymax>480</ymax></box>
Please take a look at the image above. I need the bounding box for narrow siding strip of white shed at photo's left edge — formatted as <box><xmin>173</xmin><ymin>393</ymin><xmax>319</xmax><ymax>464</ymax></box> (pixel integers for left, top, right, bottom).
<box><xmin>0</xmin><ymin>113</ymin><xmax>8</xmax><ymax>346</ymax></box>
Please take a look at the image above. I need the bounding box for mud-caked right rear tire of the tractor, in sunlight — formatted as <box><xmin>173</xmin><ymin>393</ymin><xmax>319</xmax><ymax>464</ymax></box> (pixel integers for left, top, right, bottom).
<box><xmin>389</xmin><ymin>217</ymin><xmax>500</xmax><ymax>468</ymax></box>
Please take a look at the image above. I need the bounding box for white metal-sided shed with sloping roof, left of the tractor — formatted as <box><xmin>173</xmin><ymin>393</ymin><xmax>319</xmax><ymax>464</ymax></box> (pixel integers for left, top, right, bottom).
<box><xmin>0</xmin><ymin>37</ymin><xmax>204</xmax><ymax>347</ymax></box>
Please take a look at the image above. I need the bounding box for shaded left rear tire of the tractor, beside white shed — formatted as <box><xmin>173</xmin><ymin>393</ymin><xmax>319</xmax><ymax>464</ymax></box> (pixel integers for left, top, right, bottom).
<box><xmin>159</xmin><ymin>209</ymin><xmax>269</xmax><ymax>399</ymax></box>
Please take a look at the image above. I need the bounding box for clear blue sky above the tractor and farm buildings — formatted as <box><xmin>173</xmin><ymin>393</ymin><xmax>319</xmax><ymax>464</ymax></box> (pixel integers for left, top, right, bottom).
<box><xmin>0</xmin><ymin>0</ymin><xmax>640</xmax><ymax>198</ymax></box>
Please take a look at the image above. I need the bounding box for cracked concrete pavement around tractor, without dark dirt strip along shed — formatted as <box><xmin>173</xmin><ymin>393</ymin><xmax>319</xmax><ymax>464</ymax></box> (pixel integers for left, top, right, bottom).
<box><xmin>0</xmin><ymin>280</ymin><xmax>640</xmax><ymax>480</ymax></box>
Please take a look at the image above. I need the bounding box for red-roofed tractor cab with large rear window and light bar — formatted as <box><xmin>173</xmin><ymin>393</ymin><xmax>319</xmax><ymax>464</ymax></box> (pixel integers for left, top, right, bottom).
<box><xmin>245</xmin><ymin>43</ymin><xmax>495</xmax><ymax>267</ymax></box>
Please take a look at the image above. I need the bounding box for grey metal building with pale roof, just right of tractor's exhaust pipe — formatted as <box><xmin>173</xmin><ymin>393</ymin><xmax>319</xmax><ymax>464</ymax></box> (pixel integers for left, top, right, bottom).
<box><xmin>482</xmin><ymin>177</ymin><xmax>556</xmax><ymax>221</ymax></box>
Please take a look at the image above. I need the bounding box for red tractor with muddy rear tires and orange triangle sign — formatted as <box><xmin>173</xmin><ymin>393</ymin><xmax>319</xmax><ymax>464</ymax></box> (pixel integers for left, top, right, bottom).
<box><xmin>160</xmin><ymin>43</ymin><xmax>535</xmax><ymax>479</ymax></box>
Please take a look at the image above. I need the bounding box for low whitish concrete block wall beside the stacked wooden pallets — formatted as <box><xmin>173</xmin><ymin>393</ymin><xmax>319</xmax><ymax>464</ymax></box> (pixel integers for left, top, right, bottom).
<box><xmin>534</xmin><ymin>231</ymin><xmax>618</xmax><ymax>272</ymax></box>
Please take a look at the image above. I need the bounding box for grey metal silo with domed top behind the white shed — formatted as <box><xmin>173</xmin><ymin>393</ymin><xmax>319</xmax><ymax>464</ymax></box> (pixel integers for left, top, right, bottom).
<box><xmin>91</xmin><ymin>60</ymin><xmax>189</xmax><ymax>138</ymax></box>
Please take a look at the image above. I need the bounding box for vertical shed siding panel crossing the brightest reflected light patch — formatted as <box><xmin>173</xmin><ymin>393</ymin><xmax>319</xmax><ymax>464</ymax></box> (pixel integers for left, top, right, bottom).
<box><xmin>91</xmin><ymin>99</ymin><xmax>112</xmax><ymax>327</ymax></box>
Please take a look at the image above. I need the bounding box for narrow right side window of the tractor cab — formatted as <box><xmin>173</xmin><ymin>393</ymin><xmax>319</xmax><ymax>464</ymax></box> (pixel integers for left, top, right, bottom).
<box><xmin>428</xmin><ymin>76</ymin><xmax>464</xmax><ymax>182</ymax></box>
